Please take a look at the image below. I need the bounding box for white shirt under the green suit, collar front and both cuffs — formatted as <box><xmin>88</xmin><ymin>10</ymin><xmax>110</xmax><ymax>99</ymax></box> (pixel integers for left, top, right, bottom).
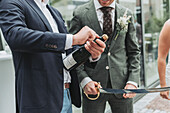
<box><xmin>80</xmin><ymin>0</ymin><xmax>138</xmax><ymax>88</ymax></box>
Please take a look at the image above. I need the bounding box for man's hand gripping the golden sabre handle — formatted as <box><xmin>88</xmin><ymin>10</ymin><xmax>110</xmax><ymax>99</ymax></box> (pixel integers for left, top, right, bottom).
<box><xmin>84</xmin><ymin>81</ymin><xmax>101</xmax><ymax>95</ymax></box>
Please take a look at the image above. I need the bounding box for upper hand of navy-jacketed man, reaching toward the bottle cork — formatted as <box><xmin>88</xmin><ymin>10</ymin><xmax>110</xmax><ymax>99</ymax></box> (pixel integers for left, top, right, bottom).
<box><xmin>72</xmin><ymin>26</ymin><xmax>99</xmax><ymax>45</ymax></box>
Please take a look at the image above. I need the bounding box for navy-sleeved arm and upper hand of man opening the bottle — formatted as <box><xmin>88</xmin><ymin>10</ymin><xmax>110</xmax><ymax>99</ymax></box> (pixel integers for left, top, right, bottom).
<box><xmin>0</xmin><ymin>1</ymin><xmax>97</xmax><ymax>53</ymax></box>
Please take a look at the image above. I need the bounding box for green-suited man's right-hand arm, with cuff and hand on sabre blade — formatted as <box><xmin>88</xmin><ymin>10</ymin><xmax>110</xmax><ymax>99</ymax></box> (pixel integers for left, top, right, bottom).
<box><xmin>123</xmin><ymin>12</ymin><xmax>140</xmax><ymax>98</ymax></box>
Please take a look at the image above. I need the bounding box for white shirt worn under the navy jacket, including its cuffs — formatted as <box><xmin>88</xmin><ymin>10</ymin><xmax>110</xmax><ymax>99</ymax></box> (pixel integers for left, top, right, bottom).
<box><xmin>34</xmin><ymin>0</ymin><xmax>73</xmax><ymax>83</ymax></box>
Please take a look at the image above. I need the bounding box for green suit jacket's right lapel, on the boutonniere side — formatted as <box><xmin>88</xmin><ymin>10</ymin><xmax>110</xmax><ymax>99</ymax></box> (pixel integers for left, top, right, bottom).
<box><xmin>108</xmin><ymin>3</ymin><xmax>123</xmax><ymax>50</ymax></box>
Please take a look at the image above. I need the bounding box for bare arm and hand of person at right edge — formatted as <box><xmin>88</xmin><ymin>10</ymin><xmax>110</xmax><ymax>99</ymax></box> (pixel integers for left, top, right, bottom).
<box><xmin>158</xmin><ymin>20</ymin><xmax>170</xmax><ymax>100</ymax></box>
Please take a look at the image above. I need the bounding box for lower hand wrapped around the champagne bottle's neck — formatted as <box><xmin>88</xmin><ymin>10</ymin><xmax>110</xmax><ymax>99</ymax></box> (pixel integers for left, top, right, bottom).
<box><xmin>85</xmin><ymin>39</ymin><xmax>106</xmax><ymax>59</ymax></box>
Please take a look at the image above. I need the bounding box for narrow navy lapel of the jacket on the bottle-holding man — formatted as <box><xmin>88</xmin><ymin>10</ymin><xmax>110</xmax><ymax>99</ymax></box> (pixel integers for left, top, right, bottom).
<box><xmin>26</xmin><ymin>0</ymin><xmax>52</xmax><ymax>32</ymax></box>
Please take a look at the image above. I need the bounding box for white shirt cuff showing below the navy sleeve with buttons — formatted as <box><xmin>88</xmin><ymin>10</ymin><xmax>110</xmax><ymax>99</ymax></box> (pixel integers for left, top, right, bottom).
<box><xmin>65</xmin><ymin>34</ymin><xmax>73</xmax><ymax>50</ymax></box>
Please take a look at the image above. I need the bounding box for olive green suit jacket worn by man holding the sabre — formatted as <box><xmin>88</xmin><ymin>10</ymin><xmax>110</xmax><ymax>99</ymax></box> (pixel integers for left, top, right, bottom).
<box><xmin>69</xmin><ymin>0</ymin><xmax>140</xmax><ymax>97</ymax></box>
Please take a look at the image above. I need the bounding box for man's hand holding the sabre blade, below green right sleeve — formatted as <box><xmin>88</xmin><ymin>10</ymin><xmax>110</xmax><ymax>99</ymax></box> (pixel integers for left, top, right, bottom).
<box><xmin>123</xmin><ymin>84</ymin><xmax>137</xmax><ymax>98</ymax></box>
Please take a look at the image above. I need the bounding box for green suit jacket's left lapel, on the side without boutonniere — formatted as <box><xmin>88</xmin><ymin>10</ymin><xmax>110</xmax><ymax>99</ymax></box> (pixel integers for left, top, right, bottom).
<box><xmin>86</xmin><ymin>0</ymin><xmax>103</xmax><ymax>35</ymax></box>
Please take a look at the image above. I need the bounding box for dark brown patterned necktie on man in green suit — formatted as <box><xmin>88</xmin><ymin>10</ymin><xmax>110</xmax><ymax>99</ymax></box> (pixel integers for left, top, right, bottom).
<box><xmin>100</xmin><ymin>7</ymin><xmax>113</xmax><ymax>38</ymax></box>
